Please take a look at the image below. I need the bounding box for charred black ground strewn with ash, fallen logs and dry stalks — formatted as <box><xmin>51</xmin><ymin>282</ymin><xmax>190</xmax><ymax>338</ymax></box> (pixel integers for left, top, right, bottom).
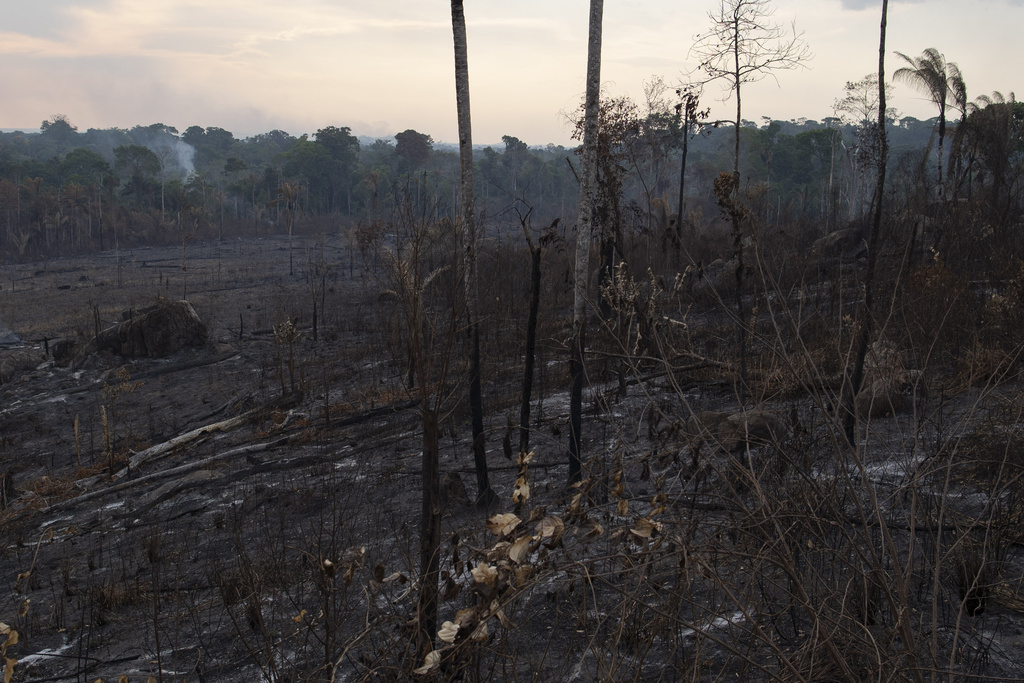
<box><xmin>0</xmin><ymin>239</ymin><xmax>1024</xmax><ymax>681</ymax></box>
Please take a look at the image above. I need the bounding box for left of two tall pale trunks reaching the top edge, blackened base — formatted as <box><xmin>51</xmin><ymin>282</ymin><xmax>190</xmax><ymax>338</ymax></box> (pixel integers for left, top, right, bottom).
<box><xmin>452</xmin><ymin>0</ymin><xmax>497</xmax><ymax>506</ymax></box>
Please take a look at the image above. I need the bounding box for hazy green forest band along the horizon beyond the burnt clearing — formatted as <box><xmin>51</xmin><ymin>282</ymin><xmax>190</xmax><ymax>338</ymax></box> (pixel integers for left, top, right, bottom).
<box><xmin>0</xmin><ymin>79</ymin><xmax>1024</xmax><ymax>259</ymax></box>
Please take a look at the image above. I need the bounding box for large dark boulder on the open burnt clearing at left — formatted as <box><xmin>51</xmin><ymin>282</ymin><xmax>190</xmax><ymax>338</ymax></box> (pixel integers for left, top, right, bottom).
<box><xmin>92</xmin><ymin>298</ymin><xmax>207</xmax><ymax>358</ymax></box>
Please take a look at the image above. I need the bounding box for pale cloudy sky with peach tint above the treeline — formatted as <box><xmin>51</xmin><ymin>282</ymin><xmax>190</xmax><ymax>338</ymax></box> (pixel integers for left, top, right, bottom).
<box><xmin>0</xmin><ymin>0</ymin><xmax>1024</xmax><ymax>144</ymax></box>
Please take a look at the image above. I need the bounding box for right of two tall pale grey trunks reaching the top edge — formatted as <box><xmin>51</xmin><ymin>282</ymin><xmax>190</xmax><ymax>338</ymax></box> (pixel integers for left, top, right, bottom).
<box><xmin>569</xmin><ymin>0</ymin><xmax>604</xmax><ymax>484</ymax></box>
